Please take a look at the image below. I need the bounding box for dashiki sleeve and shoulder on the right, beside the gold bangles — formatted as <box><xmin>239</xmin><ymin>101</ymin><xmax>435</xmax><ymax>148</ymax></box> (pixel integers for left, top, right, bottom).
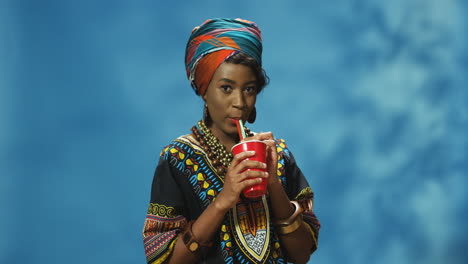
<box><xmin>276</xmin><ymin>139</ymin><xmax>320</xmax><ymax>252</ymax></box>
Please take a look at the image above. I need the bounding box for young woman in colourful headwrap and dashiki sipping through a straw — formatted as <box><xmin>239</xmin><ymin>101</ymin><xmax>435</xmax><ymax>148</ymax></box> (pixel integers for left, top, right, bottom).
<box><xmin>143</xmin><ymin>19</ymin><xmax>320</xmax><ymax>263</ymax></box>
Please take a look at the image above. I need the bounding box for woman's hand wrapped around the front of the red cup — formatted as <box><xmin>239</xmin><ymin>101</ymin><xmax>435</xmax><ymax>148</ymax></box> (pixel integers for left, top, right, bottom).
<box><xmin>215</xmin><ymin>151</ymin><xmax>268</xmax><ymax>211</ymax></box>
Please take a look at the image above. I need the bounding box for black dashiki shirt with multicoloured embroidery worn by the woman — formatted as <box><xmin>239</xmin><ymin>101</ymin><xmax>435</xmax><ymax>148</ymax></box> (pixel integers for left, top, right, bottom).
<box><xmin>143</xmin><ymin>135</ymin><xmax>320</xmax><ymax>264</ymax></box>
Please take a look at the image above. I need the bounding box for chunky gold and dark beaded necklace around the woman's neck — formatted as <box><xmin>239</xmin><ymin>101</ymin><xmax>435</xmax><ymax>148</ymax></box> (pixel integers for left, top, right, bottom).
<box><xmin>191</xmin><ymin>120</ymin><xmax>253</xmax><ymax>176</ymax></box>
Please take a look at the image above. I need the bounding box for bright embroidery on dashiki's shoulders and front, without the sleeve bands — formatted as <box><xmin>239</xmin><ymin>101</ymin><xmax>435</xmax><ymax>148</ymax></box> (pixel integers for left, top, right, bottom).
<box><xmin>161</xmin><ymin>137</ymin><xmax>288</xmax><ymax>263</ymax></box>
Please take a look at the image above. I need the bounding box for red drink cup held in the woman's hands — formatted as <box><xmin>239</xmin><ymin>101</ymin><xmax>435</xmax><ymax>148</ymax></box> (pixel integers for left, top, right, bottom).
<box><xmin>231</xmin><ymin>140</ymin><xmax>267</xmax><ymax>198</ymax></box>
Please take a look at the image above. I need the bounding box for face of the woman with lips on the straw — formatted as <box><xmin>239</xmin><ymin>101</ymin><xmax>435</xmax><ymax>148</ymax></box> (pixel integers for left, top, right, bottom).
<box><xmin>203</xmin><ymin>62</ymin><xmax>258</xmax><ymax>138</ymax></box>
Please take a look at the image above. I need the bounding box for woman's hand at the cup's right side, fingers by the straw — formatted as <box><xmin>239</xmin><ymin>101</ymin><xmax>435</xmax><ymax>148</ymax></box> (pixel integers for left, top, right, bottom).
<box><xmin>245</xmin><ymin>132</ymin><xmax>278</xmax><ymax>185</ymax></box>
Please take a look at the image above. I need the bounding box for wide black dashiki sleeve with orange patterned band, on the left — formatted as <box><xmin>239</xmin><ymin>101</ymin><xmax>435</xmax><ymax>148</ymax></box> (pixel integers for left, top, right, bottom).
<box><xmin>143</xmin><ymin>156</ymin><xmax>187</xmax><ymax>264</ymax></box>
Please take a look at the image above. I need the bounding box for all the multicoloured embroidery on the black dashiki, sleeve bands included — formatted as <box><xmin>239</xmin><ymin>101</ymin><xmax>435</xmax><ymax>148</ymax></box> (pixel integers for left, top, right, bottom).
<box><xmin>144</xmin><ymin>136</ymin><xmax>319</xmax><ymax>264</ymax></box>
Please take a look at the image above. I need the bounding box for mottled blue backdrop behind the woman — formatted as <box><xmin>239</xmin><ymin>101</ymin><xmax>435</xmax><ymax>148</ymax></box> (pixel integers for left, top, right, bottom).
<box><xmin>0</xmin><ymin>0</ymin><xmax>468</xmax><ymax>264</ymax></box>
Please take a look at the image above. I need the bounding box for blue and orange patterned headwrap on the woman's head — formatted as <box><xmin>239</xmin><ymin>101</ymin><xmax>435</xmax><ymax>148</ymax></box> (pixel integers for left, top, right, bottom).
<box><xmin>185</xmin><ymin>18</ymin><xmax>262</xmax><ymax>95</ymax></box>
